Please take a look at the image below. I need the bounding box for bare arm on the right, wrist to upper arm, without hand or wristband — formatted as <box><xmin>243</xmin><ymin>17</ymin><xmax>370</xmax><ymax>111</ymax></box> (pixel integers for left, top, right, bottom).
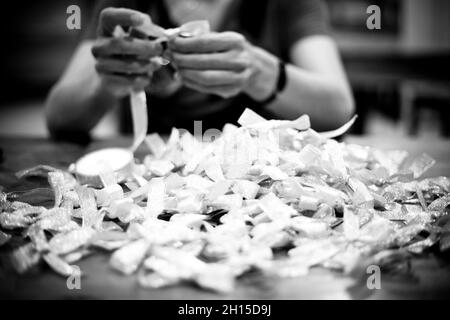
<box><xmin>246</xmin><ymin>37</ymin><xmax>354</xmax><ymax>130</ymax></box>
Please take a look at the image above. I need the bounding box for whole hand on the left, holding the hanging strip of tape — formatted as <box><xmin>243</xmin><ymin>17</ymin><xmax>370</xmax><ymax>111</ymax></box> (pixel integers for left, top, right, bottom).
<box><xmin>92</xmin><ymin>8</ymin><xmax>163</xmax><ymax>98</ymax></box>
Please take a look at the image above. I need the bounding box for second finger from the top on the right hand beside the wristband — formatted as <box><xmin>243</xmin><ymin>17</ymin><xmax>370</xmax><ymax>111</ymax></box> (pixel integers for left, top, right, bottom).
<box><xmin>172</xmin><ymin>50</ymin><xmax>250</xmax><ymax>71</ymax></box>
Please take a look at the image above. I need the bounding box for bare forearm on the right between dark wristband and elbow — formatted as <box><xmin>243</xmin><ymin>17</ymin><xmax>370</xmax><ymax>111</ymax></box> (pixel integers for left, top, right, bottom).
<box><xmin>266</xmin><ymin>65</ymin><xmax>353</xmax><ymax>130</ymax></box>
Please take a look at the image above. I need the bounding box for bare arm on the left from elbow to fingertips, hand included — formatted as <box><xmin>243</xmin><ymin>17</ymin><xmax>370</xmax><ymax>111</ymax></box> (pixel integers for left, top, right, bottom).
<box><xmin>46</xmin><ymin>8</ymin><xmax>171</xmax><ymax>138</ymax></box>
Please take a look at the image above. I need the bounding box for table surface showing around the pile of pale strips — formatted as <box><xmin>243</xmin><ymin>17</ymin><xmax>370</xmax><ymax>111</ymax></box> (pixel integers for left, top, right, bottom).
<box><xmin>0</xmin><ymin>136</ymin><xmax>450</xmax><ymax>300</ymax></box>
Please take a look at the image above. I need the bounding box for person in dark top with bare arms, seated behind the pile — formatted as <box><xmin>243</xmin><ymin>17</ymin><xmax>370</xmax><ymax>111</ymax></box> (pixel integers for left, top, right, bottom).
<box><xmin>46</xmin><ymin>0</ymin><xmax>353</xmax><ymax>138</ymax></box>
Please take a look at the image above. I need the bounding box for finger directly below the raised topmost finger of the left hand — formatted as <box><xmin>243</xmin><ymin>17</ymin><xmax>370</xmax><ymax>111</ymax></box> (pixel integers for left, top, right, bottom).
<box><xmin>92</xmin><ymin>38</ymin><xmax>163</xmax><ymax>60</ymax></box>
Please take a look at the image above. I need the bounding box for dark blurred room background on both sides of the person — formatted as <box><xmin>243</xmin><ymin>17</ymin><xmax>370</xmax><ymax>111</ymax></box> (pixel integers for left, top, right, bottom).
<box><xmin>0</xmin><ymin>0</ymin><xmax>450</xmax><ymax>138</ymax></box>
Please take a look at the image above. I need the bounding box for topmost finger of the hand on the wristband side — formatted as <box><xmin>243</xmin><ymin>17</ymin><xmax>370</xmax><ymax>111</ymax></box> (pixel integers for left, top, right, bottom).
<box><xmin>169</xmin><ymin>32</ymin><xmax>246</xmax><ymax>53</ymax></box>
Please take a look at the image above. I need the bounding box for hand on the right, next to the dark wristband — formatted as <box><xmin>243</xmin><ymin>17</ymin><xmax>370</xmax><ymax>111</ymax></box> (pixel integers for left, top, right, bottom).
<box><xmin>169</xmin><ymin>32</ymin><xmax>278</xmax><ymax>101</ymax></box>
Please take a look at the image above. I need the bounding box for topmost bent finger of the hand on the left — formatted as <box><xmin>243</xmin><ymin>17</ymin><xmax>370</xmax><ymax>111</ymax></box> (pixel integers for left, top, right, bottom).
<box><xmin>98</xmin><ymin>8</ymin><xmax>151</xmax><ymax>36</ymax></box>
